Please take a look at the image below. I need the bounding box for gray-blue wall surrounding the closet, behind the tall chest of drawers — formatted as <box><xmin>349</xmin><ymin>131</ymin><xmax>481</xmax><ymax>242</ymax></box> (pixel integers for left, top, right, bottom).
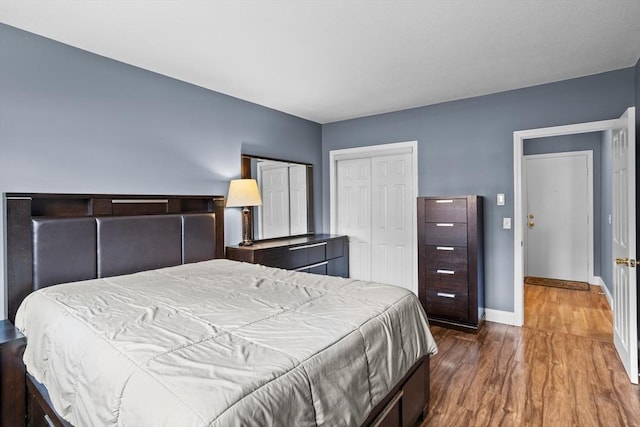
<box><xmin>322</xmin><ymin>68</ymin><xmax>637</xmax><ymax>312</ymax></box>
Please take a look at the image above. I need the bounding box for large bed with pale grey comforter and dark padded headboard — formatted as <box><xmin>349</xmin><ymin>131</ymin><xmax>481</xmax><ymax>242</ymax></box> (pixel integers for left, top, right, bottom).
<box><xmin>6</xmin><ymin>194</ymin><xmax>437</xmax><ymax>426</ymax></box>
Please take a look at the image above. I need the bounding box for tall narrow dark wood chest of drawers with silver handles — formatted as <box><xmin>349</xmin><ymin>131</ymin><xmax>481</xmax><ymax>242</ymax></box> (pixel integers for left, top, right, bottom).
<box><xmin>418</xmin><ymin>196</ymin><xmax>484</xmax><ymax>332</ymax></box>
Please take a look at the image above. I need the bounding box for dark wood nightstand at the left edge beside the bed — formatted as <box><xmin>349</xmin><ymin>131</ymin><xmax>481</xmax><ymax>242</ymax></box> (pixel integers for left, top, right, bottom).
<box><xmin>0</xmin><ymin>320</ymin><xmax>27</xmax><ymax>426</ymax></box>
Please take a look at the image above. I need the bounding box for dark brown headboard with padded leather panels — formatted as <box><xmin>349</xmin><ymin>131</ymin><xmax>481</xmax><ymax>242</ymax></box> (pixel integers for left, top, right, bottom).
<box><xmin>6</xmin><ymin>193</ymin><xmax>224</xmax><ymax>321</ymax></box>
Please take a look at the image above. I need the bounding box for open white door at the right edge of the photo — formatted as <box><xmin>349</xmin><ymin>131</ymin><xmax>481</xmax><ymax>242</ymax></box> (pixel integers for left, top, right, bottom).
<box><xmin>612</xmin><ymin>108</ymin><xmax>638</xmax><ymax>384</ymax></box>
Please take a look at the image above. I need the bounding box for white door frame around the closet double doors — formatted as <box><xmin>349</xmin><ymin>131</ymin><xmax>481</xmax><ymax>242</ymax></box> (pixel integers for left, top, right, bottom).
<box><xmin>329</xmin><ymin>141</ymin><xmax>419</xmax><ymax>295</ymax></box>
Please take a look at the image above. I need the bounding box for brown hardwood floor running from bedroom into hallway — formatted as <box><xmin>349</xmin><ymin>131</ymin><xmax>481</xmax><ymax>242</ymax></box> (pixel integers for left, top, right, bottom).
<box><xmin>422</xmin><ymin>285</ymin><xmax>640</xmax><ymax>427</ymax></box>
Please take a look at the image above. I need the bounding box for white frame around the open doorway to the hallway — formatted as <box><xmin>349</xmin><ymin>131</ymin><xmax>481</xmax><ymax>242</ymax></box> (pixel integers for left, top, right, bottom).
<box><xmin>516</xmin><ymin>119</ymin><xmax>620</xmax><ymax>326</ymax></box>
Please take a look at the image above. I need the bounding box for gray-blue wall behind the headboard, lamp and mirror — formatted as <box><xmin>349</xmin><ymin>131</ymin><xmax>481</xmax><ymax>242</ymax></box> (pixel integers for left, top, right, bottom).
<box><xmin>0</xmin><ymin>24</ymin><xmax>322</xmax><ymax>318</ymax></box>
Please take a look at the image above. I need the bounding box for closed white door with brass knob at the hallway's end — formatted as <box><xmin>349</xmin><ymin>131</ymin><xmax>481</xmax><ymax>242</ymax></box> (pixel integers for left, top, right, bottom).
<box><xmin>524</xmin><ymin>153</ymin><xmax>591</xmax><ymax>282</ymax></box>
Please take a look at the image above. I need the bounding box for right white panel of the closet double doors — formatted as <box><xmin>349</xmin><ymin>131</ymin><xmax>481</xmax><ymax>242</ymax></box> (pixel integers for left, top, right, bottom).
<box><xmin>371</xmin><ymin>154</ymin><xmax>415</xmax><ymax>290</ymax></box>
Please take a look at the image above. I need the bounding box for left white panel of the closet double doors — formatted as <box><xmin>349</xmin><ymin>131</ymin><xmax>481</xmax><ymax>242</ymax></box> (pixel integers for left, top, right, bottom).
<box><xmin>336</xmin><ymin>158</ymin><xmax>371</xmax><ymax>280</ymax></box>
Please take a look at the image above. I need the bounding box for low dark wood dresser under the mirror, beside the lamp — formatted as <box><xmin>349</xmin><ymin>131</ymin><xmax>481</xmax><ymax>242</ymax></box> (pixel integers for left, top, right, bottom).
<box><xmin>226</xmin><ymin>234</ymin><xmax>349</xmax><ymax>277</ymax></box>
